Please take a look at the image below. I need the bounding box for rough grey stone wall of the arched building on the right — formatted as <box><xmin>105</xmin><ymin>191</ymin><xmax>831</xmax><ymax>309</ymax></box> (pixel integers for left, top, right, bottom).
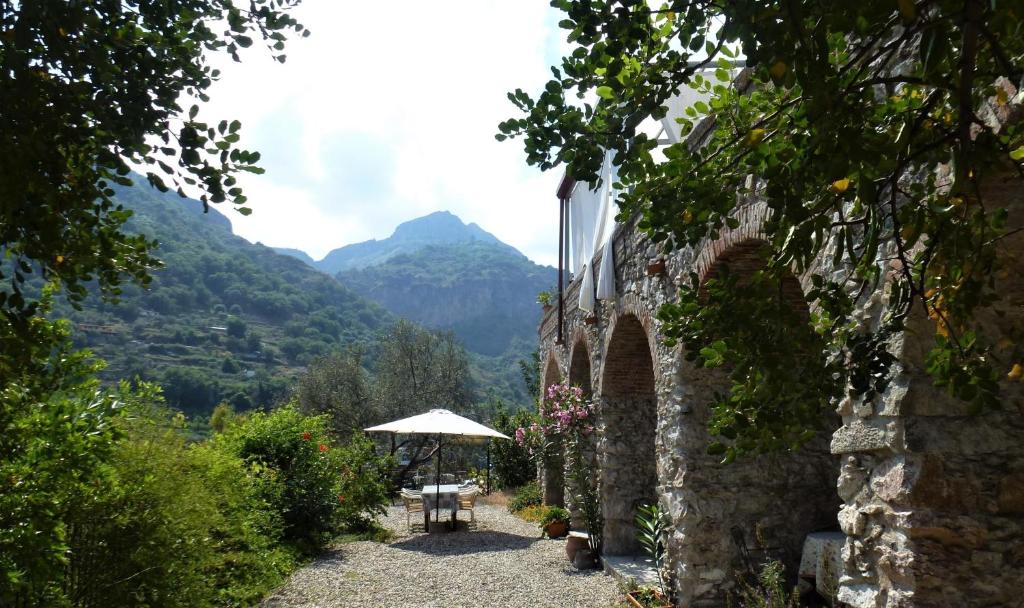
<box><xmin>540</xmin><ymin>171</ymin><xmax>1024</xmax><ymax>608</ymax></box>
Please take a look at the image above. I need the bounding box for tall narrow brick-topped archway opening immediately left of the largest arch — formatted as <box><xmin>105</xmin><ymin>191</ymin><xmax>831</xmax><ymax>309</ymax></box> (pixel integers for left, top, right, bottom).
<box><xmin>598</xmin><ymin>315</ymin><xmax>657</xmax><ymax>555</ymax></box>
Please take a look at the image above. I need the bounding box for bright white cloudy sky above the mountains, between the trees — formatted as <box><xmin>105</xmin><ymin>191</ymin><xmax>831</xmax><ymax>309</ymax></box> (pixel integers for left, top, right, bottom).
<box><xmin>201</xmin><ymin>0</ymin><xmax>565</xmax><ymax>265</ymax></box>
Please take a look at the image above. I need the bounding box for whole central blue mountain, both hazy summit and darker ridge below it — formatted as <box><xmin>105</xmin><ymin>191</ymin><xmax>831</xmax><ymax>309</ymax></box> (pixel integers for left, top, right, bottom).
<box><xmin>276</xmin><ymin>211</ymin><xmax>557</xmax><ymax>356</ymax></box>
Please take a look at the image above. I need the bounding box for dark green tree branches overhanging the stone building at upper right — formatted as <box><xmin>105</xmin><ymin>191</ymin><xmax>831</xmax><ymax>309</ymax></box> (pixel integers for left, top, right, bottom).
<box><xmin>498</xmin><ymin>0</ymin><xmax>1024</xmax><ymax>451</ymax></box>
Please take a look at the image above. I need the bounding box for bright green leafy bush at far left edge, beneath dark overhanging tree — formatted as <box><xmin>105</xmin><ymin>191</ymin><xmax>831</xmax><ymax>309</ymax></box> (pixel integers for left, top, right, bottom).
<box><xmin>0</xmin><ymin>319</ymin><xmax>119</xmax><ymax>606</ymax></box>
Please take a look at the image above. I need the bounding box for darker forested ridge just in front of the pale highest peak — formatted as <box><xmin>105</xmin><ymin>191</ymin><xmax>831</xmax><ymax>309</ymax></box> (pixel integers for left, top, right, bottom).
<box><xmin>337</xmin><ymin>241</ymin><xmax>557</xmax><ymax>356</ymax></box>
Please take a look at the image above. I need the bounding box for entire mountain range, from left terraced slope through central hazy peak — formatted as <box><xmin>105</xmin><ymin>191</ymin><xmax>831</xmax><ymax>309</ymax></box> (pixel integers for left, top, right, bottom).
<box><xmin>53</xmin><ymin>179</ymin><xmax>555</xmax><ymax>417</ymax></box>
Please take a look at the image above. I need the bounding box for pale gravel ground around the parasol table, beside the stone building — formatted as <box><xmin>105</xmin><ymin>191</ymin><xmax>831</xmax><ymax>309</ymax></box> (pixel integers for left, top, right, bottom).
<box><xmin>263</xmin><ymin>506</ymin><xmax>618</xmax><ymax>608</ymax></box>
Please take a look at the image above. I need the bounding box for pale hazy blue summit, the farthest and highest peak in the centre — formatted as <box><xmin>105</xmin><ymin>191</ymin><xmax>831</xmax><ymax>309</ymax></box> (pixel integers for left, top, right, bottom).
<box><xmin>314</xmin><ymin>211</ymin><xmax>518</xmax><ymax>275</ymax></box>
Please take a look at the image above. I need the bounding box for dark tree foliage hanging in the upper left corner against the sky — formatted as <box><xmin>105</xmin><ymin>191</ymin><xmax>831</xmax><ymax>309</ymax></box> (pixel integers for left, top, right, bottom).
<box><xmin>0</xmin><ymin>0</ymin><xmax>306</xmax><ymax>350</ymax></box>
